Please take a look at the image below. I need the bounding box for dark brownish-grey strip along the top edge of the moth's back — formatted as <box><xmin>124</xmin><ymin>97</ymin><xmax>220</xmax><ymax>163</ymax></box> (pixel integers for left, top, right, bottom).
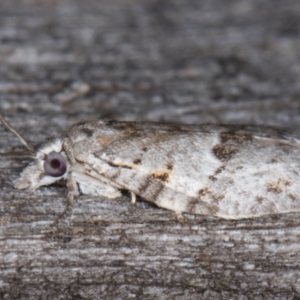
<box><xmin>66</xmin><ymin>121</ymin><xmax>300</xmax><ymax>153</ymax></box>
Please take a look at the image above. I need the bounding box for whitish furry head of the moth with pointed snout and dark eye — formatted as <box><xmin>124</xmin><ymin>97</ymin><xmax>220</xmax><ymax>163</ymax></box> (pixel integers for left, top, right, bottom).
<box><xmin>15</xmin><ymin>138</ymin><xmax>69</xmax><ymax>191</ymax></box>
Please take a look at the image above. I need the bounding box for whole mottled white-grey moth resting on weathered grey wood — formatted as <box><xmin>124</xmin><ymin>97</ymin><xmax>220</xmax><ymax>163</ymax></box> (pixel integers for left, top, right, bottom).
<box><xmin>0</xmin><ymin>111</ymin><xmax>300</xmax><ymax>219</ymax></box>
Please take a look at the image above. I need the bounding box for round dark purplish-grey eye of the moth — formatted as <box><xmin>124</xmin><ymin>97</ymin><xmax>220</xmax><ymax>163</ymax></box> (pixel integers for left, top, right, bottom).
<box><xmin>44</xmin><ymin>152</ymin><xmax>67</xmax><ymax>177</ymax></box>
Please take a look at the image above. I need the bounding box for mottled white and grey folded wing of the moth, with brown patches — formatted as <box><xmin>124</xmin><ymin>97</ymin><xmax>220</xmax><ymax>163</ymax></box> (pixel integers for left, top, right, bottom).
<box><xmin>67</xmin><ymin>122</ymin><xmax>300</xmax><ymax>219</ymax></box>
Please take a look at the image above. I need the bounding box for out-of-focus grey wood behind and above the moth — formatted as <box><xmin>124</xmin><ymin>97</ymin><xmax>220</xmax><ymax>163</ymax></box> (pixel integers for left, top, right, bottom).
<box><xmin>0</xmin><ymin>0</ymin><xmax>300</xmax><ymax>143</ymax></box>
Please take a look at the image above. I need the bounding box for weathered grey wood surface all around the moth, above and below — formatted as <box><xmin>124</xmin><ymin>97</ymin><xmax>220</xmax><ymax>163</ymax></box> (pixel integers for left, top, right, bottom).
<box><xmin>0</xmin><ymin>0</ymin><xmax>300</xmax><ymax>299</ymax></box>
